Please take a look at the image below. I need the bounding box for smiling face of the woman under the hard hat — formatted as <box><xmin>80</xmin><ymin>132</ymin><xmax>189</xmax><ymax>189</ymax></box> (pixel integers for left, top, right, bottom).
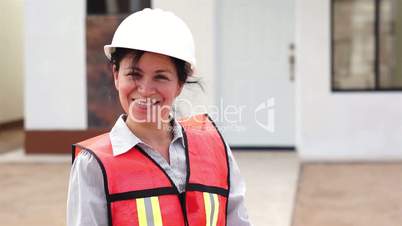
<box><xmin>113</xmin><ymin>52</ymin><xmax>183</xmax><ymax>122</ymax></box>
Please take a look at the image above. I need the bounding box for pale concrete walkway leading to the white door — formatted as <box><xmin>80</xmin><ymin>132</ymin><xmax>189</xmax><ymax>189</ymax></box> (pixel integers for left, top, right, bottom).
<box><xmin>235</xmin><ymin>151</ymin><xmax>299</xmax><ymax>226</ymax></box>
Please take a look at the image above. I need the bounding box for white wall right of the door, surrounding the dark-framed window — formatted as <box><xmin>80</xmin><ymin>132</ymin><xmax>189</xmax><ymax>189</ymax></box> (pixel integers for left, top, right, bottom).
<box><xmin>296</xmin><ymin>0</ymin><xmax>402</xmax><ymax>161</ymax></box>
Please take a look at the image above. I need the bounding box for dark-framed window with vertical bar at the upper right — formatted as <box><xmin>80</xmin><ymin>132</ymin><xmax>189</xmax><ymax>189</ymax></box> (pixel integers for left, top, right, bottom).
<box><xmin>332</xmin><ymin>0</ymin><xmax>402</xmax><ymax>91</ymax></box>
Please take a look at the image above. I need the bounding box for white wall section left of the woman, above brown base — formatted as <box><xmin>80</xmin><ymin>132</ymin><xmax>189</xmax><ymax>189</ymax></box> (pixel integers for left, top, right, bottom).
<box><xmin>24</xmin><ymin>0</ymin><xmax>87</xmax><ymax>130</ymax></box>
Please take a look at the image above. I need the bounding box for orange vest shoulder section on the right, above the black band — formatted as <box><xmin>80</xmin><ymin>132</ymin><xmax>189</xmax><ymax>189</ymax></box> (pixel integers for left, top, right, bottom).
<box><xmin>179</xmin><ymin>114</ymin><xmax>230</xmax><ymax>191</ymax></box>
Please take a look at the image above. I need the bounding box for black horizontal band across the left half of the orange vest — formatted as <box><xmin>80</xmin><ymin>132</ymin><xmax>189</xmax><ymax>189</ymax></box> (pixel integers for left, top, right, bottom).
<box><xmin>110</xmin><ymin>187</ymin><xmax>177</xmax><ymax>202</ymax></box>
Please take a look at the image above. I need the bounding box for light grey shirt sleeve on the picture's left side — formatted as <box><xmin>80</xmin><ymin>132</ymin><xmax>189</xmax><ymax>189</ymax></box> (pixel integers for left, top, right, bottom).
<box><xmin>67</xmin><ymin>151</ymin><xmax>108</xmax><ymax>226</ymax></box>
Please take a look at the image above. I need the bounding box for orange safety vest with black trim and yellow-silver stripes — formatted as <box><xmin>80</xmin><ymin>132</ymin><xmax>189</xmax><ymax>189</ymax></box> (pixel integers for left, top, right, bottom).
<box><xmin>73</xmin><ymin>114</ymin><xmax>230</xmax><ymax>226</ymax></box>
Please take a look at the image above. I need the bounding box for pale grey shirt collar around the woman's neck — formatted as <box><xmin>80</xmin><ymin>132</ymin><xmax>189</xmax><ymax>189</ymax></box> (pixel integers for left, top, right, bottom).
<box><xmin>109</xmin><ymin>114</ymin><xmax>185</xmax><ymax>156</ymax></box>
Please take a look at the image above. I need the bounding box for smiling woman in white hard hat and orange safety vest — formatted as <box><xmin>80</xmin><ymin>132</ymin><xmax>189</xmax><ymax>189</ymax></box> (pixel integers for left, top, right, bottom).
<box><xmin>67</xmin><ymin>9</ymin><xmax>250</xmax><ymax>226</ymax></box>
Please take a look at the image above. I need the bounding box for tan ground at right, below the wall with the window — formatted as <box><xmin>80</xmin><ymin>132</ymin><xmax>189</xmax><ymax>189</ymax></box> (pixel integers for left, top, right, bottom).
<box><xmin>293</xmin><ymin>162</ymin><xmax>402</xmax><ymax>226</ymax></box>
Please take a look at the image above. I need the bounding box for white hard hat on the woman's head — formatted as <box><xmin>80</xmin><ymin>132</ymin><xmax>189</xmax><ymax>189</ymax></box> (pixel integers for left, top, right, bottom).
<box><xmin>104</xmin><ymin>8</ymin><xmax>195</xmax><ymax>69</ymax></box>
